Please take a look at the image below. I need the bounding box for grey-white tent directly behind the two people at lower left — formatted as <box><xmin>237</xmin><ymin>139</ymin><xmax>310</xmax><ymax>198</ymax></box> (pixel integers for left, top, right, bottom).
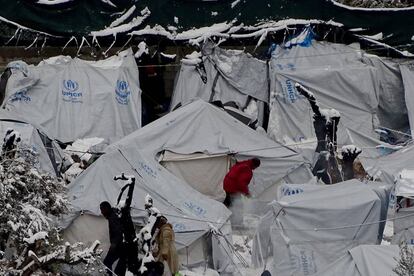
<box><xmin>61</xmin><ymin>148</ymin><xmax>231</xmax><ymax>270</ymax></box>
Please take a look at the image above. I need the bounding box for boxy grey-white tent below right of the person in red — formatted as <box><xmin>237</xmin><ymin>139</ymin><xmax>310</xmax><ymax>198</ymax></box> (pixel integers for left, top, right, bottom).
<box><xmin>253</xmin><ymin>180</ymin><xmax>388</xmax><ymax>275</ymax></box>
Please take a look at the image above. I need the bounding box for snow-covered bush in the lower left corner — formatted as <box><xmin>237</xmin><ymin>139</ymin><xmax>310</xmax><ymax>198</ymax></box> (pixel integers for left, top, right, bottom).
<box><xmin>0</xmin><ymin>131</ymin><xmax>102</xmax><ymax>275</ymax></box>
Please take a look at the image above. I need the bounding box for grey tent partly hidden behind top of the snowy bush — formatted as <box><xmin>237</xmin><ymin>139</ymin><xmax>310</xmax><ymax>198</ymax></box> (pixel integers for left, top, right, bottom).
<box><xmin>0</xmin><ymin>110</ymin><xmax>62</xmax><ymax>175</ymax></box>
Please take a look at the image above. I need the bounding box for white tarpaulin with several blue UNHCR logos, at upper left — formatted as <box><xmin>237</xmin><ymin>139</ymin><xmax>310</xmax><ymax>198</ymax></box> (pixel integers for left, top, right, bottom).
<box><xmin>3</xmin><ymin>49</ymin><xmax>141</xmax><ymax>143</ymax></box>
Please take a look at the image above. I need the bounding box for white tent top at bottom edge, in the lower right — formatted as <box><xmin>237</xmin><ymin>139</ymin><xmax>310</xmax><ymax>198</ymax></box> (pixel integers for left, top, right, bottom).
<box><xmin>318</xmin><ymin>245</ymin><xmax>399</xmax><ymax>276</ymax></box>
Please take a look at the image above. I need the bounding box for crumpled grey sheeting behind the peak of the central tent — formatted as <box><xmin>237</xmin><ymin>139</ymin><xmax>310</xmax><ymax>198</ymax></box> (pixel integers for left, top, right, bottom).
<box><xmin>171</xmin><ymin>43</ymin><xmax>269</xmax><ymax>125</ymax></box>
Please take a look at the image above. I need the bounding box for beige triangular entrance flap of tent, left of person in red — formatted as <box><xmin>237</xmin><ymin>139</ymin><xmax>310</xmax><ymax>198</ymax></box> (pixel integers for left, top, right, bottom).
<box><xmin>159</xmin><ymin>150</ymin><xmax>233</xmax><ymax>201</ymax></box>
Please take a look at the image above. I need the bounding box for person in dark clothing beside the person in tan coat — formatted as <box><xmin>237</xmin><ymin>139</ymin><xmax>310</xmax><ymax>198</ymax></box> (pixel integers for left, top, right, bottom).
<box><xmin>99</xmin><ymin>201</ymin><xmax>126</xmax><ymax>276</ymax></box>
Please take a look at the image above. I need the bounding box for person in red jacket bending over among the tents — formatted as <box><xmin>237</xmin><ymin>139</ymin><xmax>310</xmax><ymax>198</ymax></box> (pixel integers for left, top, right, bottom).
<box><xmin>223</xmin><ymin>158</ymin><xmax>260</xmax><ymax>207</ymax></box>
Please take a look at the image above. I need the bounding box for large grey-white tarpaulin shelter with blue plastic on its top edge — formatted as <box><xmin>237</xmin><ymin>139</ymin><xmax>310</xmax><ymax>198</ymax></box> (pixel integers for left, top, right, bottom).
<box><xmin>268</xmin><ymin>29</ymin><xmax>405</xmax><ymax>162</ymax></box>
